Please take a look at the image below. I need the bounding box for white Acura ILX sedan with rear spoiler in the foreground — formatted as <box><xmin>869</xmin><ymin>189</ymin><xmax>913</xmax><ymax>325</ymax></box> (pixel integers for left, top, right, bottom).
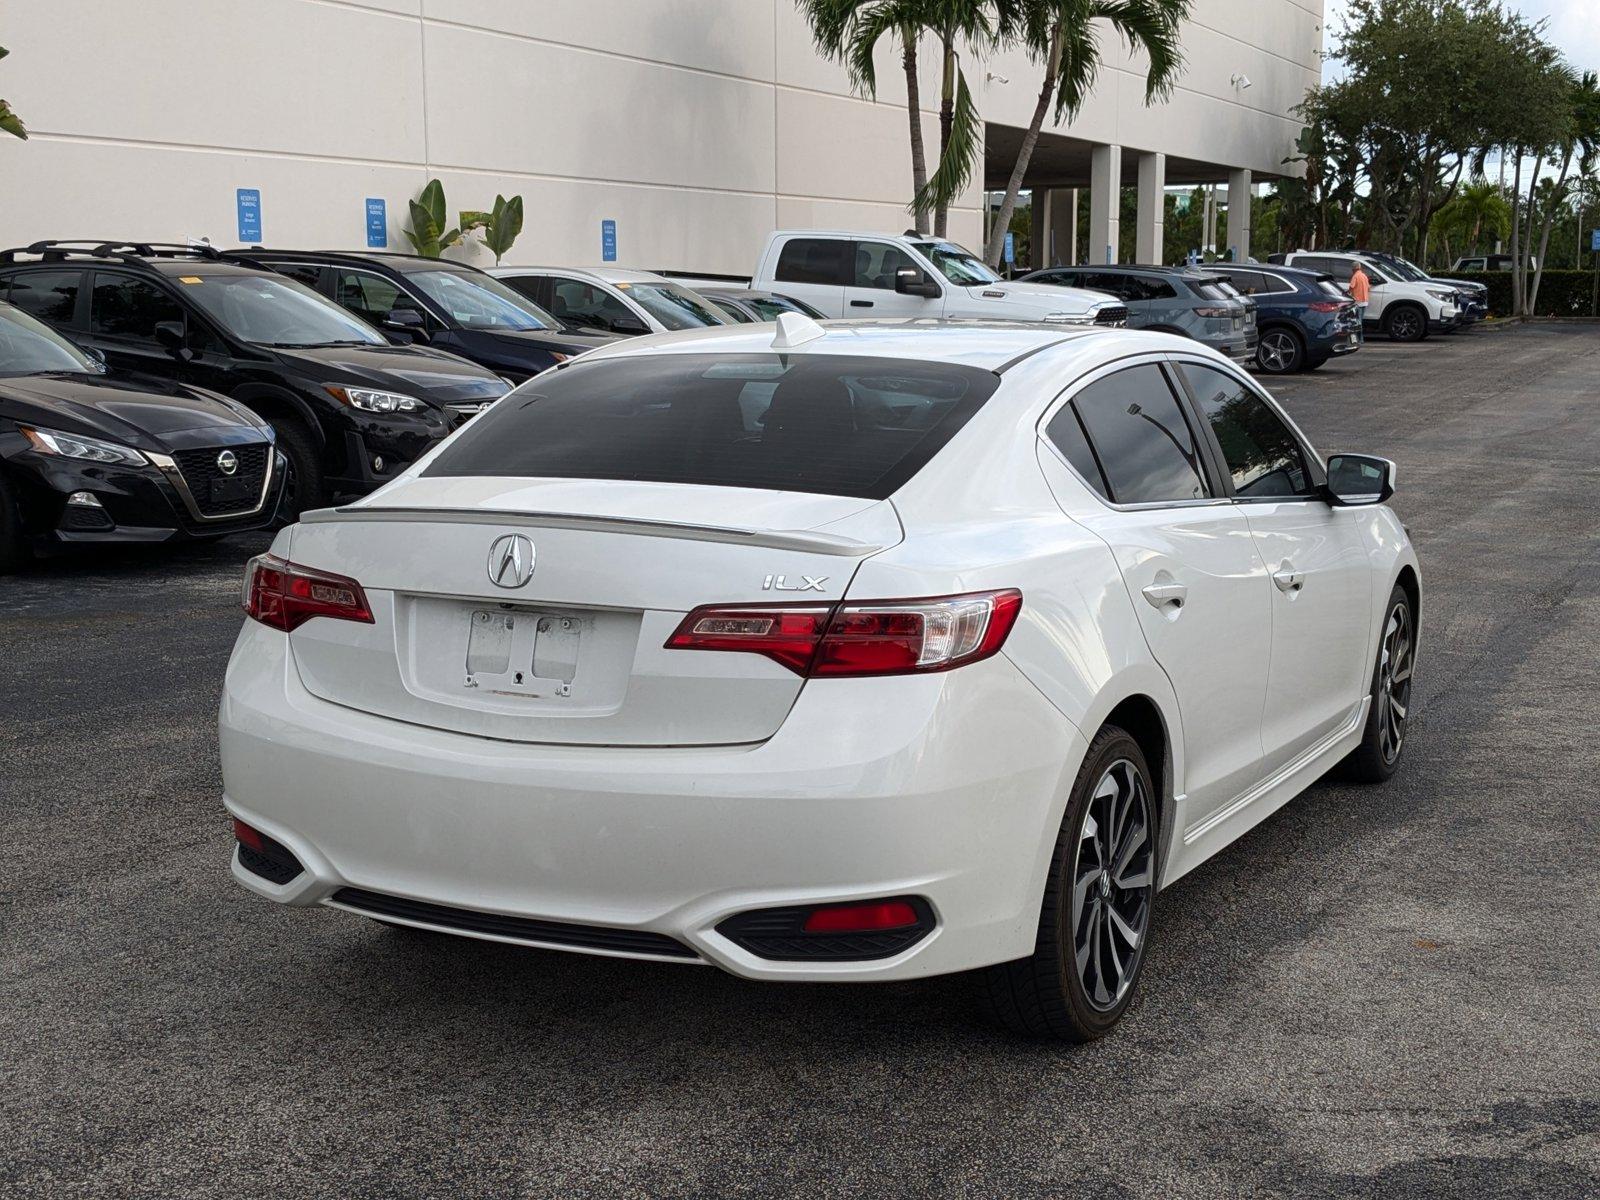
<box><xmin>221</xmin><ymin>315</ymin><xmax>1421</xmax><ymax>1040</ymax></box>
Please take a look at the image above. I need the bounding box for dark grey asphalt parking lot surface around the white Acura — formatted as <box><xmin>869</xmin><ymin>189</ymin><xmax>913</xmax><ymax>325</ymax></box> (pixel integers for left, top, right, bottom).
<box><xmin>0</xmin><ymin>325</ymin><xmax>1600</xmax><ymax>1197</ymax></box>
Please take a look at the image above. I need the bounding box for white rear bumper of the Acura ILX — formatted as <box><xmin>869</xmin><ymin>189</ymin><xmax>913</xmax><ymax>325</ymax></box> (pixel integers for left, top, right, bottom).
<box><xmin>221</xmin><ymin>622</ymin><xmax>1085</xmax><ymax>979</ymax></box>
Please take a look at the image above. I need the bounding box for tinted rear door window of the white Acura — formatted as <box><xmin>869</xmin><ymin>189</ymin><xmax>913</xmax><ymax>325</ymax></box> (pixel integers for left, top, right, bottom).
<box><xmin>1074</xmin><ymin>366</ymin><xmax>1208</xmax><ymax>504</ymax></box>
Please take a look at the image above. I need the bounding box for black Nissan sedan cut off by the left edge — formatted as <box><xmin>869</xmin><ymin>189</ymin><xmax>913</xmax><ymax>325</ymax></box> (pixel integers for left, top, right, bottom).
<box><xmin>0</xmin><ymin>304</ymin><xmax>285</xmax><ymax>573</ymax></box>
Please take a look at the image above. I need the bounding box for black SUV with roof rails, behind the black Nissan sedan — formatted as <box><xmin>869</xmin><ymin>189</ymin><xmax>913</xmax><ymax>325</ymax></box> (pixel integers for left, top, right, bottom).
<box><xmin>0</xmin><ymin>242</ymin><xmax>507</xmax><ymax>517</ymax></box>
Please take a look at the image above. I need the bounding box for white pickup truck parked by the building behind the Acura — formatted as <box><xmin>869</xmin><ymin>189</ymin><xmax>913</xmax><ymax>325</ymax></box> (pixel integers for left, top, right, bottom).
<box><xmin>750</xmin><ymin>229</ymin><xmax>1128</xmax><ymax>325</ymax></box>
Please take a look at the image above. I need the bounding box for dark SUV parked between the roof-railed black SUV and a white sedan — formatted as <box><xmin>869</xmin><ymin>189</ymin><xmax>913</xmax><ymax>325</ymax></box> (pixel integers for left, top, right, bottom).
<box><xmin>229</xmin><ymin>246</ymin><xmax>616</xmax><ymax>384</ymax></box>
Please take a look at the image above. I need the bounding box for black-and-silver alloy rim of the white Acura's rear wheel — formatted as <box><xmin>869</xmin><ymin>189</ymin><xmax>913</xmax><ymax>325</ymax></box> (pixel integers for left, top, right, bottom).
<box><xmin>1070</xmin><ymin>758</ymin><xmax>1155</xmax><ymax>1013</ymax></box>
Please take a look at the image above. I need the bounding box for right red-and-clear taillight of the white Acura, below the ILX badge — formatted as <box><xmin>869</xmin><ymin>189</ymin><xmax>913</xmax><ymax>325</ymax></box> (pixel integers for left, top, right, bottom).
<box><xmin>666</xmin><ymin>587</ymin><xmax>1022</xmax><ymax>678</ymax></box>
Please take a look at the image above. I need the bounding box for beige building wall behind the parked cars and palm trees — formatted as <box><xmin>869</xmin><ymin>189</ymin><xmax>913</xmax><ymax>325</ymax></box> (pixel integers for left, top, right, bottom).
<box><xmin>0</xmin><ymin>0</ymin><xmax>1322</xmax><ymax>272</ymax></box>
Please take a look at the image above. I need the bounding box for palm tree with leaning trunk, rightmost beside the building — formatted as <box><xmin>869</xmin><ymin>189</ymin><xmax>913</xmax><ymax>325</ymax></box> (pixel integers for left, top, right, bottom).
<box><xmin>984</xmin><ymin>0</ymin><xmax>1190</xmax><ymax>267</ymax></box>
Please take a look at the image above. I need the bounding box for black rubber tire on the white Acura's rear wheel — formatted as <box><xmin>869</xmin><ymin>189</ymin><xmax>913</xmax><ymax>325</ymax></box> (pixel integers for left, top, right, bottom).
<box><xmin>982</xmin><ymin>725</ymin><xmax>1160</xmax><ymax>1042</ymax></box>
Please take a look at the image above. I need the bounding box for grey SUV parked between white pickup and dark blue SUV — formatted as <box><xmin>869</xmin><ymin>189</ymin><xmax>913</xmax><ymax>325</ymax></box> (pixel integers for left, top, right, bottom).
<box><xmin>1022</xmin><ymin>266</ymin><xmax>1258</xmax><ymax>363</ymax></box>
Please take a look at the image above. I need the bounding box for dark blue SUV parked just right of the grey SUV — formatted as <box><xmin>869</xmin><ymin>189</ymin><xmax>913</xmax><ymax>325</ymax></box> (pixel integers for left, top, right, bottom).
<box><xmin>1200</xmin><ymin>262</ymin><xmax>1363</xmax><ymax>374</ymax></box>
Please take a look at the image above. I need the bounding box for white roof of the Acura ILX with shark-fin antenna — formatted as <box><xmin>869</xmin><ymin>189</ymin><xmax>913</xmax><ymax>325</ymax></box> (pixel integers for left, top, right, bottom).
<box><xmin>558</xmin><ymin>317</ymin><xmax>1145</xmax><ymax>373</ymax></box>
